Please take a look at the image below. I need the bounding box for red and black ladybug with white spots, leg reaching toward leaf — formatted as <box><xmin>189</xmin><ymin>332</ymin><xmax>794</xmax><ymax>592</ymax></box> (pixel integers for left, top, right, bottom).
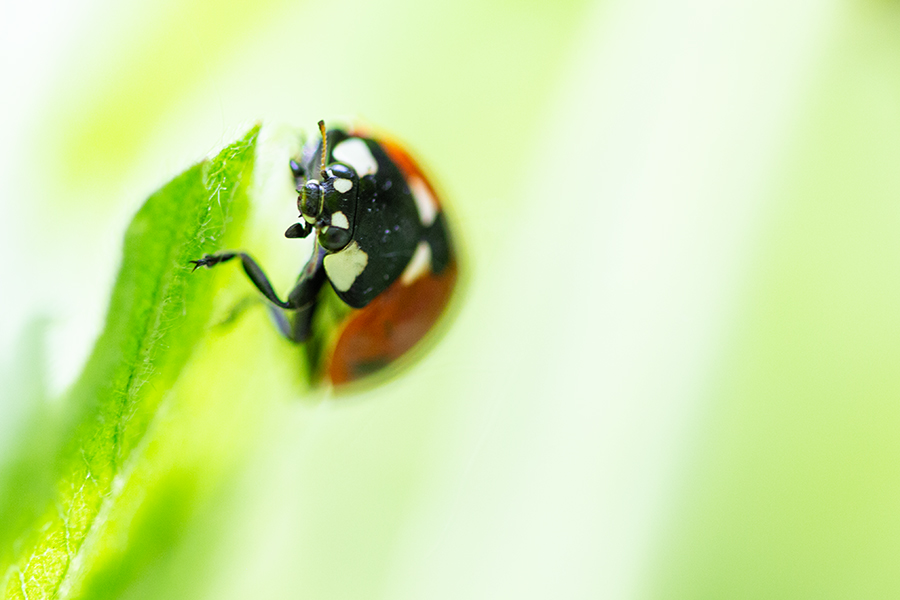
<box><xmin>191</xmin><ymin>121</ymin><xmax>457</xmax><ymax>386</ymax></box>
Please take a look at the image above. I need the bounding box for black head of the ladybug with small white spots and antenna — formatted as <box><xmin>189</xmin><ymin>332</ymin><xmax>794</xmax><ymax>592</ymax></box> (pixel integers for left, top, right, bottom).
<box><xmin>284</xmin><ymin>121</ymin><xmax>359</xmax><ymax>252</ymax></box>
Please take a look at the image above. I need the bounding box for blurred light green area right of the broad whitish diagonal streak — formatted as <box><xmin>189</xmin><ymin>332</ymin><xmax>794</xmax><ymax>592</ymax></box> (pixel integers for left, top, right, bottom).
<box><xmin>649</xmin><ymin>3</ymin><xmax>900</xmax><ymax>598</ymax></box>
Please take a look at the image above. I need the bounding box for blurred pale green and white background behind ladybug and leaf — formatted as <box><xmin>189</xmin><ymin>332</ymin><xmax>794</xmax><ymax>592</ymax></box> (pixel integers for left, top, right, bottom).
<box><xmin>0</xmin><ymin>0</ymin><xmax>900</xmax><ymax>599</ymax></box>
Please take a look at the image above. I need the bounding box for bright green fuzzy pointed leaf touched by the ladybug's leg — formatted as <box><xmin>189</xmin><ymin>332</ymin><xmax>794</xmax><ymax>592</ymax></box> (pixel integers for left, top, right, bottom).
<box><xmin>0</xmin><ymin>126</ymin><xmax>259</xmax><ymax>598</ymax></box>
